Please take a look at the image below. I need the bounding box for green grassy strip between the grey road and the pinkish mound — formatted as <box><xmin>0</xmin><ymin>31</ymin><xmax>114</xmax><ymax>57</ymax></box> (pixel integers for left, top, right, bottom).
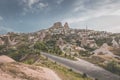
<box><xmin>31</xmin><ymin>56</ymin><xmax>92</xmax><ymax>80</ymax></box>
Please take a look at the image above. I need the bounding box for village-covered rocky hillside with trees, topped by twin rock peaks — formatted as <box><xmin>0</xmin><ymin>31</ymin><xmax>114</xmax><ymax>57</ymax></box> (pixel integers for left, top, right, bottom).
<box><xmin>0</xmin><ymin>22</ymin><xmax>120</xmax><ymax>74</ymax></box>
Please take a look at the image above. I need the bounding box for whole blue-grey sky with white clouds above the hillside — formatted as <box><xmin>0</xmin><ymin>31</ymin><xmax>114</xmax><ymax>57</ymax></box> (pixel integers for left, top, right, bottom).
<box><xmin>0</xmin><ymin>0</ymin><xmax>120</xmax><ymax>34</ymax></box>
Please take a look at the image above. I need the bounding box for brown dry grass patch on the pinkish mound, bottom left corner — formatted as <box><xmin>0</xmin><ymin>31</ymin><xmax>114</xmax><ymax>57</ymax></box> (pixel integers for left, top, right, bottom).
<box><xmin>0</xmin><ymin>63</ymin><xmax>38</xmax><ymax>80</ymax></box>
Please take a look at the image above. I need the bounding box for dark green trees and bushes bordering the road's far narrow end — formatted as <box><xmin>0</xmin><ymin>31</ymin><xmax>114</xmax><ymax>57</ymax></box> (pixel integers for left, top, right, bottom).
<box><xmin>34</xmin><ymin>40</ymin><xmax>75</xmax><ymax>60</ymax></box>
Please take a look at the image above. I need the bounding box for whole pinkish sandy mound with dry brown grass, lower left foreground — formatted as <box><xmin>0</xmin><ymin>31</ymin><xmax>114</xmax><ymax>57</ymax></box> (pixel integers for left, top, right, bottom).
<box><xmin>0</xmin><ymin>56</ymin><xmax>61</xmax><ymax>80</ymax></box>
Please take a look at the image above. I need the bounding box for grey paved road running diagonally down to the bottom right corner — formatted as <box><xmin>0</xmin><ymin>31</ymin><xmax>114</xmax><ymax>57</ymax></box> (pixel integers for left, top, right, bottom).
<box><xmin>41</xmin><ymin>52</ymin><xmax>120</xmax><ymax>80</ymax></box>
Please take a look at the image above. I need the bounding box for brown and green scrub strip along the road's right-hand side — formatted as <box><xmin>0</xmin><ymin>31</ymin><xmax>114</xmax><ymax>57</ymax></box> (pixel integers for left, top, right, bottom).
<box><xmin>82</xmin><ymin>56</ymin><xmax>120</xmax><ymax>75</ymax></box>
